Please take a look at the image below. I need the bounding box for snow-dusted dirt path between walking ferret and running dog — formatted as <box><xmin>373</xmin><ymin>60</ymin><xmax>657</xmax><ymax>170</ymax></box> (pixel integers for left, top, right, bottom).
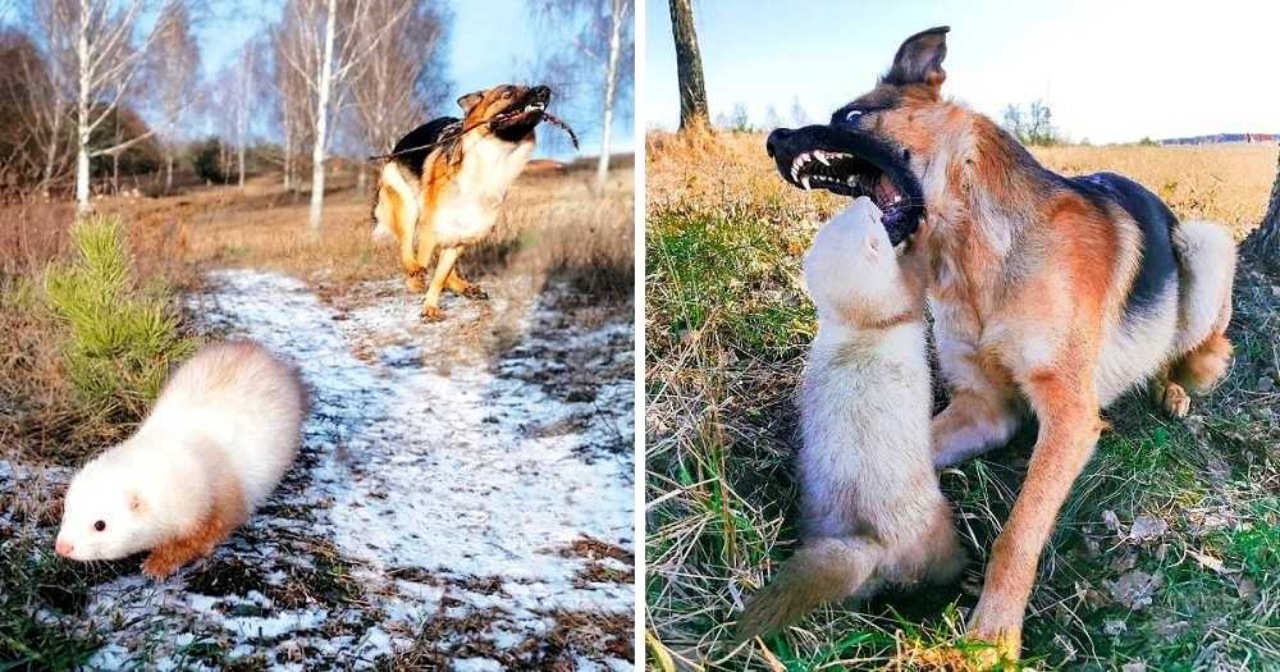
<box><xmin>43</xmin><ymin>270</ymin><xmax>635</xmax><ymax>669</ymax></box>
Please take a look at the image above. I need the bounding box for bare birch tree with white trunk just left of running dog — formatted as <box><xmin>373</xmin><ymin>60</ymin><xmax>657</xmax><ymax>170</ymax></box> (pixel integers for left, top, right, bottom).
<box><xmin>280</xmin><ymin>0</ymin><xmax>408</xmax><ymax>236</ymax></box>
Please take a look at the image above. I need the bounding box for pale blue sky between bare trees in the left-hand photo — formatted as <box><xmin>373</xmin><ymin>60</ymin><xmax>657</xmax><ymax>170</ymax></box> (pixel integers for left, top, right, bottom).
<box><xmin>197</xmin><ymin>0</ymin><xmax>629</xmax><ymax>159</ymax></box>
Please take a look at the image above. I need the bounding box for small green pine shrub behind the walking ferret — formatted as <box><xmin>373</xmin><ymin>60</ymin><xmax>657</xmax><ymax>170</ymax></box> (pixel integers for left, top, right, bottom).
<box><xmin>45</xmin><ymin>218</ymin><xmax>195</xmax><ymax>421</ymax></box>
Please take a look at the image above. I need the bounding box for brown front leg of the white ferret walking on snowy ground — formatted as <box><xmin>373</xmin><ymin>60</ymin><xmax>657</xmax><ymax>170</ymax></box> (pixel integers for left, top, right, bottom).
<box><xmin>142</xmin><ymin>465</ymin><xmax>248</xmax><ymax>581</ymax></box>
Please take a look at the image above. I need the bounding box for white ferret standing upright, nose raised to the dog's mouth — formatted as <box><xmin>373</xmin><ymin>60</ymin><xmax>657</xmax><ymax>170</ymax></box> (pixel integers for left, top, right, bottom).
<box><xmin>737</xmin><ymin>197</ymin><xmax>965</xmax><ymax>639</ymax></box>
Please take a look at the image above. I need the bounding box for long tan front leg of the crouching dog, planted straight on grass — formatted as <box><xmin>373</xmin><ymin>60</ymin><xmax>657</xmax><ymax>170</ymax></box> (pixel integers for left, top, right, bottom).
<box><xmin>969</xmin><ymin>365</ymin><xmax>1102</xmax><ymax>658</ymax></box>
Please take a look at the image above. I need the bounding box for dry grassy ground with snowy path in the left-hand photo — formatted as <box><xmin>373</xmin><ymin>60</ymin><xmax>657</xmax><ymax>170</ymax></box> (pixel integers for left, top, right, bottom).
<box><xmin>0</xmin><ymin>163</ymin><xmax>635</xmax><ymax>669</ymax></box>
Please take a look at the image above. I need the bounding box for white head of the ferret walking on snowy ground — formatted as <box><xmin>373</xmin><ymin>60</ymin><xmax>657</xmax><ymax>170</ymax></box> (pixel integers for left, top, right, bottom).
<box><xmin>55</xmin><ymin>454</ymin><xmax>159</xmax><ymax>561</ymax></box>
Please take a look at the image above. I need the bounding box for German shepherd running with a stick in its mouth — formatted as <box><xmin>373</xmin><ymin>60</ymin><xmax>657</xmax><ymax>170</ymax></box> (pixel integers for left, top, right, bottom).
<box><xmin>374</xmin><ymin>84</ymin><xmax>552</xmax><ymax>321</ymax></box>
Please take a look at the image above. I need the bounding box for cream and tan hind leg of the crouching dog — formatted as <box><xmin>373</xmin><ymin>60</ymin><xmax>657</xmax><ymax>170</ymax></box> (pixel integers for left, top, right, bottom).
<box><xmin>1171</xmin><ymin>220</ymin><xmax>1235</xmax><ymax>392</ymax></box>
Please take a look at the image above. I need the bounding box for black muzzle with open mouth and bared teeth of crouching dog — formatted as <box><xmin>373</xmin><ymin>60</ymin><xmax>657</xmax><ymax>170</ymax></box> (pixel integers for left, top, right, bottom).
<box><xmin>767</xmin><ymin>125</ymin><xmax>924</xmax><ymax>244</ymax></box>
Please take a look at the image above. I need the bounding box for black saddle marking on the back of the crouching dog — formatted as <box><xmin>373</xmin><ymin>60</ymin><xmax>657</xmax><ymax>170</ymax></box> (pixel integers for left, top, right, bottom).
<box><xmin>1068</xmin><ymin>173</ymin><xmax>1178</xmax><ymax>319</ymax></box>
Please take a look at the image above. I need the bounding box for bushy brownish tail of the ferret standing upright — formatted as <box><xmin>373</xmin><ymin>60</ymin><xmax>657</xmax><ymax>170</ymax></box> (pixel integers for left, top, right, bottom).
<box><xmin>737</xmin><ymin>538</ymin><xmax>884</xmax><ymax>641</ymax></box>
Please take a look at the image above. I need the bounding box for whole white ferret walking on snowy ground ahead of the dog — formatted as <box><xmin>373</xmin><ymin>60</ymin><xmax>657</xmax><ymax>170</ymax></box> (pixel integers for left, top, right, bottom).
<box><xmin>55</xmin><ymin>340</ymin><xmax>307</xmax><ymax>579</ymax></box>
